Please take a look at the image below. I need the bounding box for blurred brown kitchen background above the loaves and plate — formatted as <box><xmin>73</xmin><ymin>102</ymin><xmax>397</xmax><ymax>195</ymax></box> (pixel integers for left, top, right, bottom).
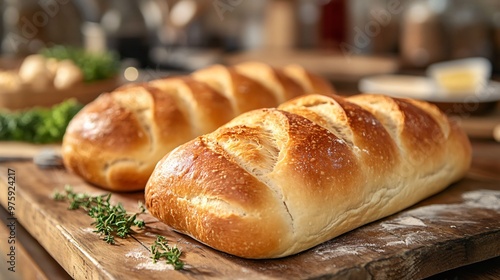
<box><xmin>0</xmin><ymin>0</ymin><xmax>500</xmax><ymax>89</ymax></box>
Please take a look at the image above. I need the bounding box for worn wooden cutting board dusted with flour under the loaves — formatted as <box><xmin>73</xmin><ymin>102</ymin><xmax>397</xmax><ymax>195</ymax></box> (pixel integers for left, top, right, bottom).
<box><xmin>0</xmin><ymin>145</ymin><xmax>500</xmax><ymax>279</ymax></box>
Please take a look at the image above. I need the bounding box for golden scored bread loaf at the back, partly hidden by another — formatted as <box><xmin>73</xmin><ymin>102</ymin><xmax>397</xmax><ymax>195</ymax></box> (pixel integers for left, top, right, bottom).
<box><xmin>62</xmin><ymin>62</ymin><xmax>333</xmax><ymax>191</ymax></box>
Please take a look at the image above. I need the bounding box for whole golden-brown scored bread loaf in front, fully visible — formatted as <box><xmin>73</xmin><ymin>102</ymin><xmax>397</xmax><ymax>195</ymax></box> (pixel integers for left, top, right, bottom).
<box><xmin>145</xmin><ymin>94</ymin><xmax>471</xmax><ymax>259</ymax></box>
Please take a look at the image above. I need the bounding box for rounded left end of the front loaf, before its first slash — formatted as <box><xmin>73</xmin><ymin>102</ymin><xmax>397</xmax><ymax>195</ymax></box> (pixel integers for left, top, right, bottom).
<box><xmin>145</xmin><ymin>137</ymin><xmax>289</xmax><ymax>257</ymax></box>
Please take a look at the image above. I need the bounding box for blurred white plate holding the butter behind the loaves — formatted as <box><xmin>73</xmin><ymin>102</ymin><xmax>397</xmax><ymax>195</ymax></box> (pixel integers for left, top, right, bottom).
<box><xmin>358</xmin><ymin>75</ymin><xmax>500</xmax><ymax>103</ymax></box>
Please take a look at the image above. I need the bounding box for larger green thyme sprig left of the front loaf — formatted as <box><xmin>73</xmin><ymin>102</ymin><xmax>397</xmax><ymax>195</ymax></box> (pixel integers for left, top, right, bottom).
<box><xmin>54</xmin><ymin>186</ymin><xmax>146</xmax><ymax>244</ymax></box>
